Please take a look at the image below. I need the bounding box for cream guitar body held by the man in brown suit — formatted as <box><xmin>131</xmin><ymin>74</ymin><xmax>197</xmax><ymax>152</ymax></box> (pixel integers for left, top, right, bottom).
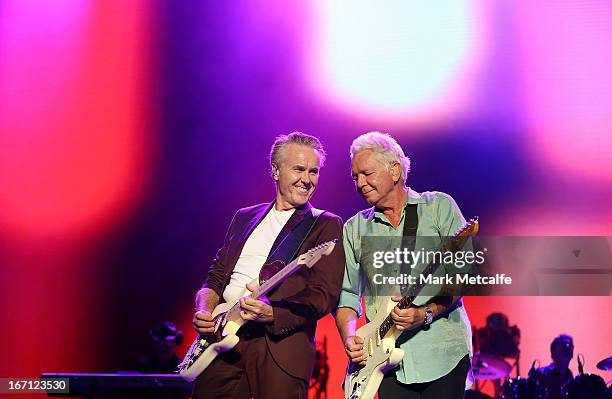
<box><xmin>179</xmin><ymin>286</ymin><xmax>251</xmax><ymax>382</ymax></box>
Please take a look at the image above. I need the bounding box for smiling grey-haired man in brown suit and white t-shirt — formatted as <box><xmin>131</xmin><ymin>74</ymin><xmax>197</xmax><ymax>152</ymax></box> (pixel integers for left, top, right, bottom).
<box><xmin>193</xmin><ymin>132</ymin><xmax>344</xmax><ymax>399</ymax></box>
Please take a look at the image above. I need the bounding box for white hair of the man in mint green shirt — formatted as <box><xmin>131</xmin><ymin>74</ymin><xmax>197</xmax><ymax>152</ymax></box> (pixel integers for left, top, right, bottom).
<box><xmin>351</xmin><ymin>132</ymin><xmax>410</xmax><ymax>183</ymax></box>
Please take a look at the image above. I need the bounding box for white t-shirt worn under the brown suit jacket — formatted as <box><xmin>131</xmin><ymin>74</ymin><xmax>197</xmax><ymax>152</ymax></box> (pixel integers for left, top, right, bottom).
<box><xmin>223</xmin><ymin>206</ymin><xmax>295</xmax><ymax>302</ymax></box>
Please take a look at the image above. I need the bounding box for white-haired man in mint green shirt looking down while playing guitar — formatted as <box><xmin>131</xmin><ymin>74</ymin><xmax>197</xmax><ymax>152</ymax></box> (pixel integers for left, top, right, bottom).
<box><xmin>336</xmin><ymin>132</ymin><xmax>472</xmax><ymax>399</ymax></box>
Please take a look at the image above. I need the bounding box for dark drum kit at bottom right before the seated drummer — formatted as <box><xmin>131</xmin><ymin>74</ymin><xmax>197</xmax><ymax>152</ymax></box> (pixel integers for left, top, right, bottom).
<box><xmin>465</xmin><ymin>353</ymin><xmax>612</xmax><ymax>399</ymax></box>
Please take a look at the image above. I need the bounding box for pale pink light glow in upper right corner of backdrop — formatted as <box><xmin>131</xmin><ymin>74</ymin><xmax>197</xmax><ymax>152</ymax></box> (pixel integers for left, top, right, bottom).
<box><xmin>516</xmin><ymin>1</ymin><xmax>612</xmax><ymax>181</ymax></box>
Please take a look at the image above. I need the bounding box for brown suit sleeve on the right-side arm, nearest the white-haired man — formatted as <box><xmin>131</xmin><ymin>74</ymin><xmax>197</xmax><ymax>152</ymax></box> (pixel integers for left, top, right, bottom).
<box><xmin>267</xmin><ymin>217</ymin><xmax>344</xmax><ymax>335</ymax></box>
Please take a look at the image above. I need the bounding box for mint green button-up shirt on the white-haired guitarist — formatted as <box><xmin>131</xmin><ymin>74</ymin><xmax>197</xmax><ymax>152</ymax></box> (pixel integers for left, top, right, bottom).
<box><xmin>338</xmin><ymin>189</ymin><xmax>472</xmax><ymax>385</ymax></box>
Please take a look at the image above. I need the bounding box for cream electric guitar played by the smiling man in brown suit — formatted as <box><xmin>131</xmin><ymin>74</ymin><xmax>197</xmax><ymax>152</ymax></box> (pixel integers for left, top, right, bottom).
<box><xmin>178</xmin><ymin>240</ymin><xmax>337</xmax><ymax>381</ymax></box>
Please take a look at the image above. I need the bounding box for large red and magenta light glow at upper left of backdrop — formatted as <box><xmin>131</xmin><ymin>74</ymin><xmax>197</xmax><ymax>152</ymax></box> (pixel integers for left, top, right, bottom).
<box><xmin>0</xmin><ymin>1</ymin><xmax>148</xmax><ymax>235</ymax></box>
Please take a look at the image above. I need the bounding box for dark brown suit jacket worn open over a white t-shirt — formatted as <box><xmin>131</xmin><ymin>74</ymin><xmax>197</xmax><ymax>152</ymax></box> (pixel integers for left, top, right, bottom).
<box><xmin>204</xmin><ymin>203</ymin><xmax>344</xmax><ymax>381</ymax></box>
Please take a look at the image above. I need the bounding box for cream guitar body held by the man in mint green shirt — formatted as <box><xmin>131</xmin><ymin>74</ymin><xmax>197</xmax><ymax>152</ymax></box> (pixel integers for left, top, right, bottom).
<box><xmin>344</xmin><ymin>297</ymin><xmax>404</xmax><ymax>399</ymax></box>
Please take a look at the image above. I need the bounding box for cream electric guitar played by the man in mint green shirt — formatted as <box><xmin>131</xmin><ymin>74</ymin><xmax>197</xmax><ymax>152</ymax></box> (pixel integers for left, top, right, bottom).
<box><xmin>344</xmin><ymin>217</ymin><xmax>478</xmax><ymax>399</ymax></box>
